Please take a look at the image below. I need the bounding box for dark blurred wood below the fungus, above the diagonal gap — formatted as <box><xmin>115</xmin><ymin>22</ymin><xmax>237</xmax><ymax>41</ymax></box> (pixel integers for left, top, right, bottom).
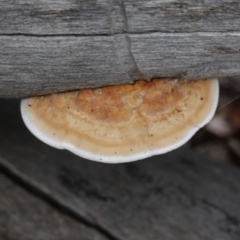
<box><xmin>0</xmin><ymin>100</ymin><xmax>240</xmax><ymax>240</ymax></box>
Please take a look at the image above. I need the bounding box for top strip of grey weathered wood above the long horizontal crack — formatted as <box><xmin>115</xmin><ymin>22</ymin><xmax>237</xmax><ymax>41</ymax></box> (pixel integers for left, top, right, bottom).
<box><xmin>0</xmin><ymin>0</ymin><xmax>240</xmax><ymax>35</ymax></box>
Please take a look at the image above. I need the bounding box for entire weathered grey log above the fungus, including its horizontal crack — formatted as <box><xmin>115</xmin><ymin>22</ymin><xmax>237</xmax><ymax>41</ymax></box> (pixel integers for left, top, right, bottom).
<box><xmin>0</xmin><ymin>0</ymin><xmax>240</xmax><ymax>98</ymax></box>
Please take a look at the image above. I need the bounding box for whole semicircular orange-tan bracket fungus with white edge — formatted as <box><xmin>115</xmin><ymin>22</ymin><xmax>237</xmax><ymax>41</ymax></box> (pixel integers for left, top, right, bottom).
<box><xmin>21</xmin><ymin>79</ymin><xmax>219</xmax><ymax>163</ymax></box>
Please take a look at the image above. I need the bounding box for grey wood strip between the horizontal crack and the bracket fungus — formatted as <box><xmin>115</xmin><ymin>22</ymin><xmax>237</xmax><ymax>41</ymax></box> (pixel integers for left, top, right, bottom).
<box><xmin>0</xmin><ymin>33</ymin><xmax>240</xmax><ymax>97</ymax></box>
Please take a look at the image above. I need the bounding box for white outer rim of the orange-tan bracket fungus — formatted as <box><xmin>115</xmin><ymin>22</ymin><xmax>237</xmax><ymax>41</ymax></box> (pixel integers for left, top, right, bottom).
<box><xmin>21</xmin><ymin>79</ymin><xmax>219</xmax><ymax>163</ymax></box>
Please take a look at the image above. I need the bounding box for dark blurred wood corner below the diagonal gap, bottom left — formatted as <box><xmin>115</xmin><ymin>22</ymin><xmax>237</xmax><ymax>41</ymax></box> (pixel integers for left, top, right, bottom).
<box><xmin>0</xmin><ymin>174</ymin><xmax>107</xmax><ymax>240</ymax></box>
